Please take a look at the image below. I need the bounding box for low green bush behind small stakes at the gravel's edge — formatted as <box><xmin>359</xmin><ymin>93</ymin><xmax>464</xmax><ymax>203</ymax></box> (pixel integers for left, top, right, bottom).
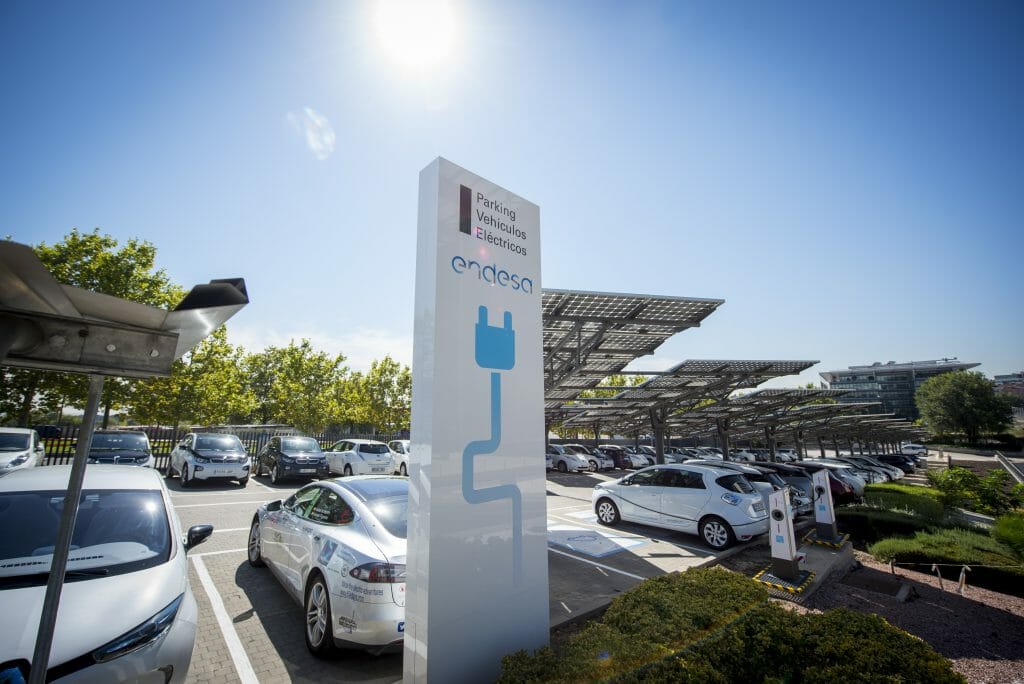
<box><xmin>868</xmin><ymin>529</ymin><xmax>1024</xmax><ymax>596</ymax></box>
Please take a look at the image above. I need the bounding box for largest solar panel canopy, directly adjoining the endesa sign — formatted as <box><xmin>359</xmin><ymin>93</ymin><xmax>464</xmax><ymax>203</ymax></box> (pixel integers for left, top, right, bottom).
<box><xmin>543</xmin><ymin>290</ymin><xmax>725</xmax><ymax>410</ymax></box>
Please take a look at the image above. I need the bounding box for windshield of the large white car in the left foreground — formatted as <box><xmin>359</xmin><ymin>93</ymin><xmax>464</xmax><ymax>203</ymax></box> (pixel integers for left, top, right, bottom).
<box><xmin>0</xmin><ymin>489</ymin><xmax>171</xmax><ymax>589</ymax></box>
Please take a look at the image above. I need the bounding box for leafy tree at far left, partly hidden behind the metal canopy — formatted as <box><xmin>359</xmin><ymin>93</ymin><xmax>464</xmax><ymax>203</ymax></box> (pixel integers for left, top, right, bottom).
<box><xmin>3</xmin><ymin>228</ymin><xmax>184</xmax><ymax>427</ymax></box>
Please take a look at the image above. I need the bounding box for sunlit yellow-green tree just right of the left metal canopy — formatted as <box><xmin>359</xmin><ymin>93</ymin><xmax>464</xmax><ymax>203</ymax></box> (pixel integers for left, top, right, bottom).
<box><xmin>131</xmin><ymin>326</ymin><xmax>253</xmax><ymax>426</ymax></box>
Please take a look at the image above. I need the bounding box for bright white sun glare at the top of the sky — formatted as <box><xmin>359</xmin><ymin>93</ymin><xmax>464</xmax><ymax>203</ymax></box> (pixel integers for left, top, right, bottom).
<box><xmin>376</xmin><ymin>0</ymin><xmax>456</xmax><ymax>72</ymax></box>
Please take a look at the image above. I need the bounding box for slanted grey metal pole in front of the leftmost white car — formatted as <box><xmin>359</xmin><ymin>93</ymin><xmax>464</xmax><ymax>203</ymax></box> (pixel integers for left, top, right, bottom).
<box><xmin>29</xmin><ymin>375</ymin><xmax>103</xmax><ymax>684</ymax></box>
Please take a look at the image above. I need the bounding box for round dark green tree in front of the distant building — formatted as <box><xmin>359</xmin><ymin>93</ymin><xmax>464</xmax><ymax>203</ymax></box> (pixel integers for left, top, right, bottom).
<box><xmin>914</xmin><ymin>371</ymin><xmax>1013</xmax><ymax>443</ymax></box>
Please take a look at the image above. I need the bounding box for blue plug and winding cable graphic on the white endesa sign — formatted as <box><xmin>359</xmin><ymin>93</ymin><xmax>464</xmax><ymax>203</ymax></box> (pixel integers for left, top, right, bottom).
<box><xmin>462</xmin><ymin>305</ymin><xmax>522</xmax><ymax>587</ymax></box>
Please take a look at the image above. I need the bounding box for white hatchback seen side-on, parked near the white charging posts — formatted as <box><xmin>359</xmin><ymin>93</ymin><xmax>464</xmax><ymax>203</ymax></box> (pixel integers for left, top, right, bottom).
<box><xmin>591</xmin><ymin>464</ymin><xmax>768</xmax><ymax>550</ymax></box>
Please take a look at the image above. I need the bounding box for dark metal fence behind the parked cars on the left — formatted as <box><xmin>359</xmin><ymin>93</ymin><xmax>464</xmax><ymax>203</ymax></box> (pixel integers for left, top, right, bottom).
<box><xmin>43</xmin><ymin>425</ymin><xmax>409</xmax><ymax>468</ymax></box>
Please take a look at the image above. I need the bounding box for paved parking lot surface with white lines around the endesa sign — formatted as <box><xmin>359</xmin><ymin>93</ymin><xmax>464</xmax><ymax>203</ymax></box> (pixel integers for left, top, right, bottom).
<box><xmin>174</xmin><ymin>471</ymin><xmax>729</xmax><ymax>684</ymax></box>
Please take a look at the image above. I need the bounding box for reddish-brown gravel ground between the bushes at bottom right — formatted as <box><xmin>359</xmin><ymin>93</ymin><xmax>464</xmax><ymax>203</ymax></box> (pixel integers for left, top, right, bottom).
<box><xmin>721</xmin><ymin>547</ymin><xmax>1024</xmax><ymax>684</ymax></box>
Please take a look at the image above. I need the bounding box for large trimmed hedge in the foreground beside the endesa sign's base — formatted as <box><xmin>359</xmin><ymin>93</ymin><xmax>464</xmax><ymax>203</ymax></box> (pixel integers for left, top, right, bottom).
<box><xmin>499</xmin><ymin>568</ymin><xmax>964</xmax><ymax>684</ymax></box>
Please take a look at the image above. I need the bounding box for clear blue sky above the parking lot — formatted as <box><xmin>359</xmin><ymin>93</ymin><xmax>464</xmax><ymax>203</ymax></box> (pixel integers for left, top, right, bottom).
<box><xmin>0</xmin><ymin>0</ymin><xmax>1024</xmax><ymax>385</ymax></box>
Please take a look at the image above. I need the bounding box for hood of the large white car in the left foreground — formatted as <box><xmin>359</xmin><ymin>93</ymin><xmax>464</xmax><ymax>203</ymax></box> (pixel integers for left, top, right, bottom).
<box><xmin>0</xmin><ymin>550</ymin><xmax>186</xmax><ymax>668</ymax></box>
